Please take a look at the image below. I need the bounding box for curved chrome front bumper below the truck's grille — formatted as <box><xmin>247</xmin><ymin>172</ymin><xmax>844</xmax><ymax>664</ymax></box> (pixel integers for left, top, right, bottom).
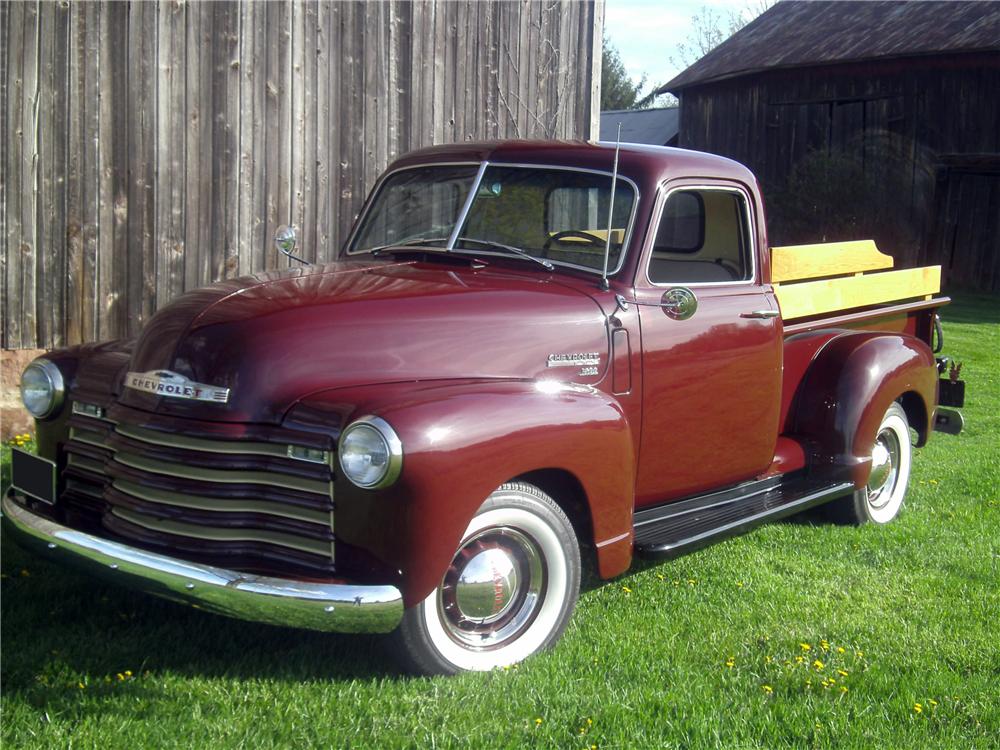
<box><xmin>2</xmin><ymin>490</ymin><xmax>403</xmax><ymax>633</ymax></box>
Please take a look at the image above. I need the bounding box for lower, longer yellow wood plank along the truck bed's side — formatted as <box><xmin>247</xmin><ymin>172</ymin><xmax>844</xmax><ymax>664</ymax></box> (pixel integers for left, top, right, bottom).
<box><xmin>775</xmin><ymin>266</ymin><xmax>941</xmax><ymax>320</ymax></box>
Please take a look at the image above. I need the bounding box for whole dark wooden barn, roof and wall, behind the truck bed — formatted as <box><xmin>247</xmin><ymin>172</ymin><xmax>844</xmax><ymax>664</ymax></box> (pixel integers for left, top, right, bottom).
<box><xmin>660</xmin><ymin>0</ymin><xmax>1000</xmax><ymax>291</ymax></box>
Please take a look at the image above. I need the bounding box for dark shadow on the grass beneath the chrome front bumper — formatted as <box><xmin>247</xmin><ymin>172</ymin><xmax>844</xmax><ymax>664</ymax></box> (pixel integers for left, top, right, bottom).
<box><xmin>0</xmin><ymin>535</ymin><xmax>411</xmax><ymax>711</ymax></box>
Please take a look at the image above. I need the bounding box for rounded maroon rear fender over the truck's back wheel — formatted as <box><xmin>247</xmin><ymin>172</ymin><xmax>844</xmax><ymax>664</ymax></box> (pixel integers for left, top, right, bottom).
<box><xmin>792</xmin><ymin>332</ymin><xmax>937</xmax><ymax>489</ymax></box>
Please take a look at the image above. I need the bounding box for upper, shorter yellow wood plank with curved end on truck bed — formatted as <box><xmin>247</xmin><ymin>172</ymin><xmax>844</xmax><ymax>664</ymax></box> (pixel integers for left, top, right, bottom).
<box><xmin>771</xmin><ymin>240</ymin><xmax>892</xmax><ymax>283</ymax></box>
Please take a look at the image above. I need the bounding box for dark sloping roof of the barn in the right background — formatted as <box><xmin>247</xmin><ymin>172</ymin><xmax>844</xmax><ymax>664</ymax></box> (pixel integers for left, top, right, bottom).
<box><xmin>657</xmin><ymin>0</ymin><xmax>1000</xmax><ymax>93</ymax></box>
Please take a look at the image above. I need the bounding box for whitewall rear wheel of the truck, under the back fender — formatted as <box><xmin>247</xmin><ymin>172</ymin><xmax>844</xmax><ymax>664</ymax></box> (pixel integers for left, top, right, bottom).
<box><xmin>829</xmin><ymin>403</ymin><xmax>913</xmax><ymax>525</ymax></box>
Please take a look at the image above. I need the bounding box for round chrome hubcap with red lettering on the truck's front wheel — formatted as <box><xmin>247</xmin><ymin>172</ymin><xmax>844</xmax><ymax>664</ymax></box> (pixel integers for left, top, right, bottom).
<box><xmin>438</xmin><ymin>527</ymin><xmax>545</xmax><ymax>650</ymax></box>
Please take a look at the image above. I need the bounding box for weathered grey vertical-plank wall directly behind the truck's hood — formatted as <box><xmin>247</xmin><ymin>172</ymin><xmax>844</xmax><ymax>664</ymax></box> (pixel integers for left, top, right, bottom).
<box><xmin>0</xmin><ymin>0</ymin><xmax>603</xmax><ymax>348</ymax></box>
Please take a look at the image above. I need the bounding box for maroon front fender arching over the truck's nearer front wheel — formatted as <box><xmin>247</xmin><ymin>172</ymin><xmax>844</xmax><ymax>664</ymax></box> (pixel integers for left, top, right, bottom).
<box><xmin>296</xmin><ymin>381</ymin><xmax>635</xmax><ymax>606</ymax></box>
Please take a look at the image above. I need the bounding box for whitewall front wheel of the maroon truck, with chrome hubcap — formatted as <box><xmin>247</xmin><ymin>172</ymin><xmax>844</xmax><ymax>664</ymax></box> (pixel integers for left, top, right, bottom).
<box><xmin>393</xmin><ymin>482</ymin><xmax>580</xmax><ymax>674</ymax></box>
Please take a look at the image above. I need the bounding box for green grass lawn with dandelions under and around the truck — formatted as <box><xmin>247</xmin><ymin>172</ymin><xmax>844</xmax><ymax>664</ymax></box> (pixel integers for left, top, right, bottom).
<box><xmin>0</xmin><ymin>295</ymin><xmax>1000</xmax><ymax>750</ymax></box>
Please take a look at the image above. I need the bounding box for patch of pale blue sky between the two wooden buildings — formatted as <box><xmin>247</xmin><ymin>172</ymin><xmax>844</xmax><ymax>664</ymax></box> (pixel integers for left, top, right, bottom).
<box><xmin>604</xmin><ymin>0</ymin><xmax>751</xmax><ymax>93</ymax></box>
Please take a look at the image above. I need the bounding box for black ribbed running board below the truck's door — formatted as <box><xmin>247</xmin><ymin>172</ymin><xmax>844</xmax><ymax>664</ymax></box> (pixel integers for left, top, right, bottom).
<box><xmin>633</xmin><ymin>477</ymin><xmax>854</xmax><ymax>560</ymax></box>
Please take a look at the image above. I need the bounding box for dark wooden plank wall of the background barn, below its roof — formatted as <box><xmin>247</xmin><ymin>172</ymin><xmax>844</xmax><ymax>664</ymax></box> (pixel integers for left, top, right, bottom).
<box><xmin>679</xmin><ymin>52</ymin><xmax>1000</xmax><ymax>291</ymax></box>
